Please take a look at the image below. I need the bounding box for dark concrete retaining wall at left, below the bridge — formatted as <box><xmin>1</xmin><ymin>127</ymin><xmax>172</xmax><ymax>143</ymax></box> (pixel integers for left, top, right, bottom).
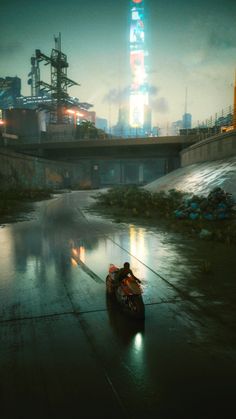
<box><xmin>0</xmin><ymin>148</ymin><xmax>91</xmax><ymax>189</ymax></box>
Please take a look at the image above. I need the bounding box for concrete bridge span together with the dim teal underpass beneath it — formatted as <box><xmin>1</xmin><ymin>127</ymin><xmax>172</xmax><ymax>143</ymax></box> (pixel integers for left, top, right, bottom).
<box><xmin>8</xmin><ymin>136</ymin><xmax>196</xmax><ymax>188</ymax></box>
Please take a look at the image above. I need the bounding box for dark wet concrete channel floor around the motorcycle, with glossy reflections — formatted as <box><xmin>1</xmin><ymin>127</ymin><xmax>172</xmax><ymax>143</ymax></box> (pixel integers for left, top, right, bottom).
<box><xmin>0</xmin><ymin>192</ymin><xmax>236</xmax><ymax>419</ymax></box>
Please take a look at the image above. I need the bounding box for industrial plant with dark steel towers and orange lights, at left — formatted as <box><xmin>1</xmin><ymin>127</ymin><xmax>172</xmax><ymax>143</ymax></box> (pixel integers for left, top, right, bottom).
<box><xmin>0</xmin><ymin>35</ymin><xmax>96</xmax><ymax>142</ymax></box>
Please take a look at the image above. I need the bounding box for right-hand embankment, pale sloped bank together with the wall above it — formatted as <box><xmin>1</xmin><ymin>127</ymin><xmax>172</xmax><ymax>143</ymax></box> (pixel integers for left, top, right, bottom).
<box><xmin>145</xmin><ymin>131</ymin><xmax>236</xmax><ymax>200</ymax></box>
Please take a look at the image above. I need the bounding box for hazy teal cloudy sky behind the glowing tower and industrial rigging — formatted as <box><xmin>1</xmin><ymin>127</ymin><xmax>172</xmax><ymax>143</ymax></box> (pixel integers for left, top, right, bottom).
<box><xmin>0</xmin><ymin>0</ymin><xmax>236</xmax><ymax>126</ymax></box>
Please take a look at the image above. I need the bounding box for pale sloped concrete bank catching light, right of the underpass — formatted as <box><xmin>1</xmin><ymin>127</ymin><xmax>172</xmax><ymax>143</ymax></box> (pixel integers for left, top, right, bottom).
<box><xmin>144</xmin><ymin>156</ymin><xmax>236</xmax><ymax>200</ymax></box>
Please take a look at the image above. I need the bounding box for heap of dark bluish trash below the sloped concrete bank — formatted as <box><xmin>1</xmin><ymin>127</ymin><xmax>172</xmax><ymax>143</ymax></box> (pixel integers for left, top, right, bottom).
<box><xmin>174</xmin><ymin>187</ymin><xmax>235</xmax><ymax>221</ymax></box>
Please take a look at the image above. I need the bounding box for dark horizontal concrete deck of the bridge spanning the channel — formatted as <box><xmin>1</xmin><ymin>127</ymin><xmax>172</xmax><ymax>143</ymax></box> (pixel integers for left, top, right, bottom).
<box><xmin>10</xmin><ymin>135</ymin><xmax>197</xmax><ymax>161</ymax></box>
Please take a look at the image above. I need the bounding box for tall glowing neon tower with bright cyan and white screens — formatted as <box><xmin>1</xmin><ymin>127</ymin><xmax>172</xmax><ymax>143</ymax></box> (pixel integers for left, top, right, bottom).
<box><xmin>129</xmin><ymin>0</ymin><xmax>148</xmax><ymax>130</ymax></box>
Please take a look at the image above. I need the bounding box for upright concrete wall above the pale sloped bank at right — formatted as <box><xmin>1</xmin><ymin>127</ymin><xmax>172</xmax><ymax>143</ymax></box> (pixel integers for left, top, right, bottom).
<box><xmin>181</xmin><ymin>131</ymin><xmax>236</xmax><ymax>167</ymax></box>
